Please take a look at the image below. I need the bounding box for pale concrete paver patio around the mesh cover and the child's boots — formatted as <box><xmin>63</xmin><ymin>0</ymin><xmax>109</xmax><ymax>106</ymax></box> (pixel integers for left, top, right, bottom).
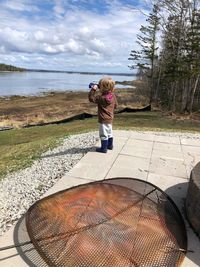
<box><xmin>0</xmin><ymin>131</ymin><xmax>200</xmax><ymax>267</ymax></box>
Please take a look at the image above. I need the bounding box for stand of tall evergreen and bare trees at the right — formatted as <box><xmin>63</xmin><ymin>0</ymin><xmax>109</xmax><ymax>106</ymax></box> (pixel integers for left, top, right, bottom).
<box><xmin>129</xmin><ymin>0</ymin><xmax>200</xmax><ymax>114</ymax></box>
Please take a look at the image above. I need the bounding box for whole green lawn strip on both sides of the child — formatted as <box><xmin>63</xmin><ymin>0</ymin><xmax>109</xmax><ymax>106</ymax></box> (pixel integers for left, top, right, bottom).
<box><xmin>0</xmin><ymin>112</ymin><xmax>200</xmax><ymax>178</ymax></box>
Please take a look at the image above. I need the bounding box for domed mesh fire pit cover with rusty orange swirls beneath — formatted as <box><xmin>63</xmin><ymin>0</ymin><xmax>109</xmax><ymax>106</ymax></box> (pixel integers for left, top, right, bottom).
<box><xmin>26</xmin><ymin>178</ymin><xmax>187</xmax><ymax>267</ymax></box>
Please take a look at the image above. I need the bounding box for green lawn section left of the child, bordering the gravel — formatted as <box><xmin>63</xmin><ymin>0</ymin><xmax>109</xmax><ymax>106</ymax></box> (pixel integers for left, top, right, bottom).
<box><xmin>0</xmin><ymin>119</ymin><xmax>97</xmax><ymax>178</ymax></box>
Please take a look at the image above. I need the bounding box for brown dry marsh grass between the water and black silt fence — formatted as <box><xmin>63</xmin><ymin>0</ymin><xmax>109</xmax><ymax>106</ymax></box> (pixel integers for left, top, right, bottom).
<box><xmin>0</xmin><ymin>89</ymin><xmax>148</xmax><ymax>128</ymax></box>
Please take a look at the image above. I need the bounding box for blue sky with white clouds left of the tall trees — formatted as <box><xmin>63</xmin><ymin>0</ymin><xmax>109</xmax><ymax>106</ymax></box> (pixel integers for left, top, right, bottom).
<box><xmin>0</xmin><ymin>0</ymin><xmax>149</xmax><ymax>73</ymax></box>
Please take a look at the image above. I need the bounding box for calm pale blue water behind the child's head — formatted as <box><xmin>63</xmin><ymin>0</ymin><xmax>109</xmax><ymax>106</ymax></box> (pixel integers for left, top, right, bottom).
<box><xmin>0</xmin><ymin>72</ymin><xmax>134</xmax><ymax>96</ymax></box>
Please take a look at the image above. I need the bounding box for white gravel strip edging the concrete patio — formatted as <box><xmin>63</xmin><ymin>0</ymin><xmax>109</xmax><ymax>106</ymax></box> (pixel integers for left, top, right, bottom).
<box><xmin>0</xmin><ymin>131</ymin><xmax>200</xmax><ymax>235</ymax></box>
